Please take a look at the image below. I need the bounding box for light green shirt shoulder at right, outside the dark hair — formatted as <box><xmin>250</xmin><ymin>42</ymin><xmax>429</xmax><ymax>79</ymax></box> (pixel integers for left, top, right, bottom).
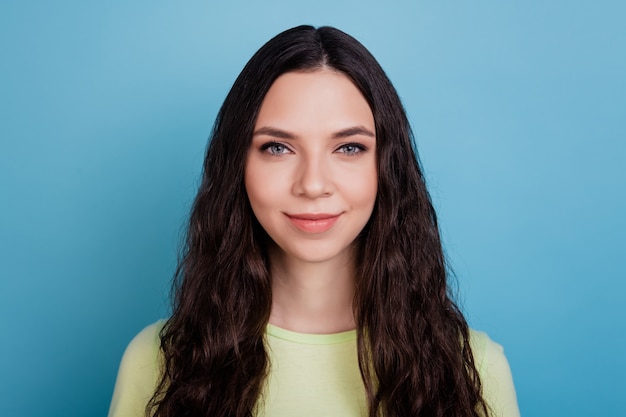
<box><xmin>470</xmin><ymin>329</ymin><xmax>520</xmax><ymax>417</ymax></box>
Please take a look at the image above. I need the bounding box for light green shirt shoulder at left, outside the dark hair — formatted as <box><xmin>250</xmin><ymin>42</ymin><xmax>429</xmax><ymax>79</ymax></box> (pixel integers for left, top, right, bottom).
<box><xmin>109</xmin><ymin>320</ymin><xmax>165</xmax><ymax>417</ymax></box>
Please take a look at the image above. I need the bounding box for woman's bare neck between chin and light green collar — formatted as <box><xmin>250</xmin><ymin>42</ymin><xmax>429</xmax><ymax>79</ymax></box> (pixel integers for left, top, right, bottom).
<box><xmin>270</xmin><ymin>245</ymin><xmax>356</xmax><ymax>334</ymax></box>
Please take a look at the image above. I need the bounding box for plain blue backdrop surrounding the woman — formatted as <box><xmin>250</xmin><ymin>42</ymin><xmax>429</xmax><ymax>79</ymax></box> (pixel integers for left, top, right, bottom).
<box><xmin>0</xmin><ymin>0</ymin><xmax>626</xmax><ymax>417</ymax></box>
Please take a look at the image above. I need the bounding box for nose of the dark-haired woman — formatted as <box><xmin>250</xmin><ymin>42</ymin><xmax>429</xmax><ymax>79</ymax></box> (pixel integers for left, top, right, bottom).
<box><xmin>293</xmin><ymin>155</ymin><xmax>333</xmax><ymax>198</ymax></box>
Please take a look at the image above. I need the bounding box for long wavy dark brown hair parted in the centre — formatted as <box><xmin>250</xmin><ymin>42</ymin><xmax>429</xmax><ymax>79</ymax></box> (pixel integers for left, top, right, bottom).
<box><xmin>146</xmin><ymin>26</ymin><xmax>488</xmax><ymax>417</ymax></box>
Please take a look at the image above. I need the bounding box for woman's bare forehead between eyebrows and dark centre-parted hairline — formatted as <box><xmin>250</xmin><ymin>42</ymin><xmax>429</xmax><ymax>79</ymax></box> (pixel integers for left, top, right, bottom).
<box><xmin>256</xmin><ymin>69</ymin><xmax>374</xmax><ymax>130</ymax></box>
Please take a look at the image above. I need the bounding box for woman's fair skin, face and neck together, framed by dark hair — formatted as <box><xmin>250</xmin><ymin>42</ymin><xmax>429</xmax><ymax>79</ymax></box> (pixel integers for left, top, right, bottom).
<box><xmin>245</xmin><ymin>69</ymin><xmax>377</xmax><ymax>333</ymax></box>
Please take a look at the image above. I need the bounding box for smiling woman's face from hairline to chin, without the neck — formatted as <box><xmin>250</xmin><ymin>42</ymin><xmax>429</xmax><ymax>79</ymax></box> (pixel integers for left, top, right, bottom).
<box><xmin>245</xmin><ymin>70</ymin><xmax>378</xmax><ymax>262</ymax></box>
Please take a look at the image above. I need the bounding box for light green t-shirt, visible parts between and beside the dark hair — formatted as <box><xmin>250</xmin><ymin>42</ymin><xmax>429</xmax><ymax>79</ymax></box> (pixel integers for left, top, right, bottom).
<box><xmin>109</xmin><ymin>321</ymin><xmax>519</xmax><ymax>417</ymax></box>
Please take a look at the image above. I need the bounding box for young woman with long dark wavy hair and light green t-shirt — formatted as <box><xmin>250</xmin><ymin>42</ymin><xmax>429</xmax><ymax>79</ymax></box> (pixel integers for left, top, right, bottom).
<box><xmin>109</xmin><ymin>26</ymin><xmax>519</xmax><ymax>417</ymax></box>
